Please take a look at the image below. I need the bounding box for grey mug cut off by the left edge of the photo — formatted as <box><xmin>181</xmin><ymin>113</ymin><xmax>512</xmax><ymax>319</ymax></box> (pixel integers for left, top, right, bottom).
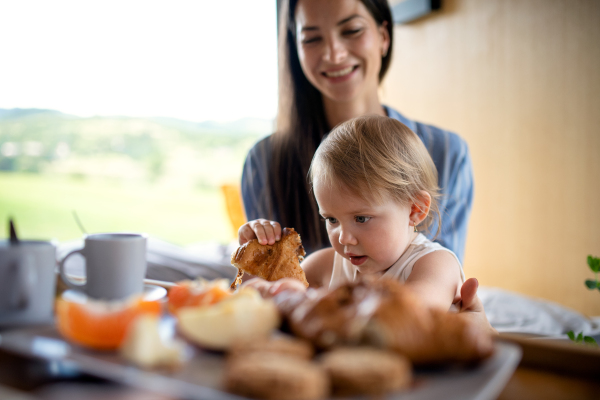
<box><xmin>0</xmin><ymin>240</ymin><xmax>56</xmax><ymax>327</ymax></box>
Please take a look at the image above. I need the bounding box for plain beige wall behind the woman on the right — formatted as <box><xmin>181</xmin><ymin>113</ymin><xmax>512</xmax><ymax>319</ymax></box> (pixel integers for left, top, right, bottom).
<box><xmin>382</xmin><ymin>0</ymin><xmax>600</xmax><ymax>315</ymax></box>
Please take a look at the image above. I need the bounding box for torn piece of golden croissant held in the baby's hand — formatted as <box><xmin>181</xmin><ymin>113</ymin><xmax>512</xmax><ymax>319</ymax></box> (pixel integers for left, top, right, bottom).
<box><xmin>231</xmin><ymin>228</ymin><xmax>308</xmax><ymax>287</ymax></box>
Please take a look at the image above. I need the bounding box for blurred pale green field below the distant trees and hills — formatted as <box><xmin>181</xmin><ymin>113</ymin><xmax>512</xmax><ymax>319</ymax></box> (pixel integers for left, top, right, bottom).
<box><xmin>0</xmin><ymin>172</ymin><xmax>234</xmax><ymax>245</ymax></box>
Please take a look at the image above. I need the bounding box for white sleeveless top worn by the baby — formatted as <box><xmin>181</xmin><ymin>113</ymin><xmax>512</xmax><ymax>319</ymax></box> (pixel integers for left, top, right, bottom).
<box><xmin>329</xmin><ymin>233</ymin><xmax>465</xmax><ymax>289</ymax></box>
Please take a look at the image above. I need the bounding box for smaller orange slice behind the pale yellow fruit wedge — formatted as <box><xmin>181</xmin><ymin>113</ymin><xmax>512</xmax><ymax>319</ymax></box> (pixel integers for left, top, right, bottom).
<box><xmin>169</xmin><ymin>279</ymin><xmax>232</xmax><ymax>313</ymax></box>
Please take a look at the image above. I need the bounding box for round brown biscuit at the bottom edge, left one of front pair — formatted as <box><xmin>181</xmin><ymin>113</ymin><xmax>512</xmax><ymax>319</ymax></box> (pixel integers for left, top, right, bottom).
<box><xmin>224</xmin><ymin>352</ymin><xmax>329</xmax><ymax>400</ymax></box>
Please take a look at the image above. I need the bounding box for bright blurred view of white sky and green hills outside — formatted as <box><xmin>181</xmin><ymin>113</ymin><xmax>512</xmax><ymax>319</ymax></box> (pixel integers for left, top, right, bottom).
<box><xmin>0</xmin><ymin>0</ymin><xmax>277</xmax><ymax>245</ymax></box>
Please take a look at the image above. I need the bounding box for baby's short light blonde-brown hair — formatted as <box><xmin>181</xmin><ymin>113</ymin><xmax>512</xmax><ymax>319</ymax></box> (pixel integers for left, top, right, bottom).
<box><xmin>309</xmin><ymin>115</ymin><xmax>441</xmax><ymax>234</ymax></box>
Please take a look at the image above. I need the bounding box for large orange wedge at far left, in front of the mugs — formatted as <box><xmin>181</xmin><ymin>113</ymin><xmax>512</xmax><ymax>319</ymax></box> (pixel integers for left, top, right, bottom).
<box><xmin>56</xmin><ymin>297</ymin><xmax>161</xmax><ymax>350</ymax></box>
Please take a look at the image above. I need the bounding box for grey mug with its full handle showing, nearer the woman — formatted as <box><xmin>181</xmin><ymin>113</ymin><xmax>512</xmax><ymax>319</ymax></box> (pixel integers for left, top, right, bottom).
<box><xmin>59</xmin><ymin>233</ymin><xmax>146</xmax><ymax>300</ymax></box>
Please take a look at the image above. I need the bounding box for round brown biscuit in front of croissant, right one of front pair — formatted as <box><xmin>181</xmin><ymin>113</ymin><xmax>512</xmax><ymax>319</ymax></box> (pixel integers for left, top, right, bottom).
<box><xmin>320</xmin><ymin>347</ymin><xmax>412</xmax><ymax>396</ymax></box>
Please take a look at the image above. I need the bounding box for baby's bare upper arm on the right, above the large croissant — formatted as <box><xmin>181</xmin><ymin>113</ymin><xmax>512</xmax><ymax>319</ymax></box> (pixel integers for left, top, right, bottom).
<box><xmin>406</xmin><ymin>250</ymin><xmax>461</xmax><ymax>310</ymax></box>
